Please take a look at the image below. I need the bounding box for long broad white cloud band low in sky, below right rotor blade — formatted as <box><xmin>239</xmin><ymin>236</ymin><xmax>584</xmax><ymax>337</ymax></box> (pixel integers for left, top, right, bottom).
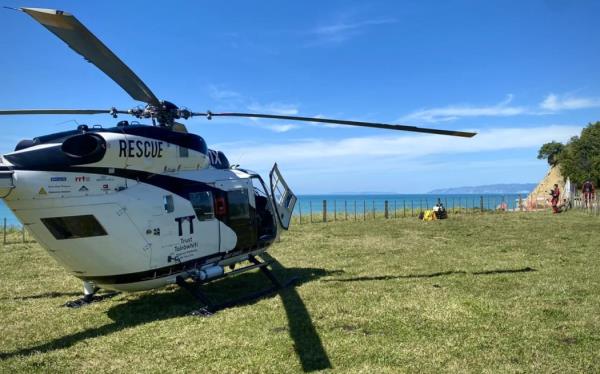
<box><xmin>220</xmin><ymin>125</ymin><xmax>582</xmax><ymax>174</ymax></box>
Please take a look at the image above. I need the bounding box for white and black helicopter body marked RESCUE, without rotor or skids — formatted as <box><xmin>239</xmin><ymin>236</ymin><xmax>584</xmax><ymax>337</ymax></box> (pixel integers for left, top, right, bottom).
<box><xmin>0</xmin><ymin>125</ymin><xmax>295</xmax><ymax>291</ymax></box>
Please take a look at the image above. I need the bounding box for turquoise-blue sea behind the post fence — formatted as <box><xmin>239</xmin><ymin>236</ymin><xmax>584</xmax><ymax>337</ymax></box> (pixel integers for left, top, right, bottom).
<box><xmin>0</xmin><ymin>194</ymin><xmax>527</xmax><ymax>226</ymax></box>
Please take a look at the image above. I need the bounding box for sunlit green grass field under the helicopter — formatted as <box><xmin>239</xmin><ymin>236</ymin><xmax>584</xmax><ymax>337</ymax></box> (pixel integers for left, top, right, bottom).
<box><xmin>0</xmin><ymin>212</ymin><xmax>600</xmax><ymax>373</ymax></box>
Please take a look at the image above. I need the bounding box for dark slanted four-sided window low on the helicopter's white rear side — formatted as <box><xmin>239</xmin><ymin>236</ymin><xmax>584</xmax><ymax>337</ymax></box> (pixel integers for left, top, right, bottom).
<box><xmin>40</xmin><ymin>214</ymin><xmax>108</xmax><ymax>240</ymax></box>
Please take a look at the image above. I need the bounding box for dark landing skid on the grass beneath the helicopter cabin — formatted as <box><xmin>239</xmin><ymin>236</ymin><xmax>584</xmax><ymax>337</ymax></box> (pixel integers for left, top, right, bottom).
<box><xmin>175</xmin><ymin>255</ymin><xmax>297</xmax><ymax>317</ymax></box>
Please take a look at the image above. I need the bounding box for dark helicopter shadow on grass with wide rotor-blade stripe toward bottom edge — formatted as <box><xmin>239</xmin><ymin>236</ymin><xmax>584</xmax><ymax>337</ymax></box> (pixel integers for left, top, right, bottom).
<box><xmin>0</xmin><ymin>256</ymin><xmax>341</xmax><ymax>372</ymax></box>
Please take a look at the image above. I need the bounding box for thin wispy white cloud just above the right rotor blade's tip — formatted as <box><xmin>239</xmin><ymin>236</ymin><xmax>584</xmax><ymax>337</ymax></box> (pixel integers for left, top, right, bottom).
<box><xmin>399</xmin><ymin>95</ymin><xmax>529</xmax><ymax>122</ymax></box>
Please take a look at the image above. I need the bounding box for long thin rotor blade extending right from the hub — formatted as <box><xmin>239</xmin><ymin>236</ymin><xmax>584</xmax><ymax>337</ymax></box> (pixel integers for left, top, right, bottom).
<box><xmin>204</xmin><ymin>112</ymin><xmax>477</xmax><ymax>138</ymax></box>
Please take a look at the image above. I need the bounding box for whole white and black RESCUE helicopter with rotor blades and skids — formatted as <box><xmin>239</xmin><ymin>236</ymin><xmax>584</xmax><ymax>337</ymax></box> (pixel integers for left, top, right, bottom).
<box><xmin>0</xmin><ymin>8</ymin><xmax>475</xmax><ymax>314</ymax></box>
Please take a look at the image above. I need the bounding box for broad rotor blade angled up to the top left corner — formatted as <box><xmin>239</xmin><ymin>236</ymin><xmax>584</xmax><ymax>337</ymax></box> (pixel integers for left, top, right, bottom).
<box><xmin>20</xmin><ymin>8</ymin><xmax>159</xmax><ymax>105</ymax></box>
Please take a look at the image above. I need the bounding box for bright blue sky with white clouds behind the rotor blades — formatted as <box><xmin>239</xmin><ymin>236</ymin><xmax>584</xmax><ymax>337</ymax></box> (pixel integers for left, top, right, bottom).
<box><xmin>0</xmin><ymin>0</ymin><xmax>600</xmax><ymax>194</ymax></box>
